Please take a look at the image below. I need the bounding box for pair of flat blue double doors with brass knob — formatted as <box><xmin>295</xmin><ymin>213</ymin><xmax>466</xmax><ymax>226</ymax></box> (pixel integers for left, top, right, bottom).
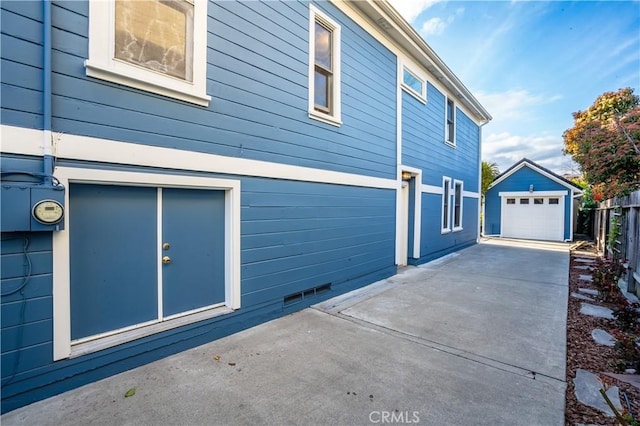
<box><xmin>68</xmin><ymin>184</ymin><xmax>225</xmax><ymax>340</ymax></box>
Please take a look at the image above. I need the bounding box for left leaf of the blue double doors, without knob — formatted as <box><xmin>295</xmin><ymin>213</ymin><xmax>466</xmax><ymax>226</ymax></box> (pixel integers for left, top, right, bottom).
<box><xmin>67</xmin><ymin>184</ymin><xmax>158</xmax><ymax>340</ymax></box>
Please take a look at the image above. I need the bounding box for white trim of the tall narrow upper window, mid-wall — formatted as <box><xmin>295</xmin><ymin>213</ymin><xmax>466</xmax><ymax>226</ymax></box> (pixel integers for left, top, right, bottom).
<box><xmin>308</xmin><ymin>5</ymin><xmax>342</xmax><ymax>126</ymax></box>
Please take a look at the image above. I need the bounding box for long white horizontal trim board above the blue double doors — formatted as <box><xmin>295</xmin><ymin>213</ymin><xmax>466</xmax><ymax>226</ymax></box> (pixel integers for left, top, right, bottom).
<box><xmin>1</xmin><ymin>125</ymin><xmax>399</xmax><ymax>189</ymax></box>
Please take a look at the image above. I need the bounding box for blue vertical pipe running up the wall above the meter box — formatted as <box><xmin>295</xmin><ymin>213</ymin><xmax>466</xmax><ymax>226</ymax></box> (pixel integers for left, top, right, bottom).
<box><xmin>42</xmin><ymin>0</ymin><xmax>54</xmax><ymax>186</ymax></box>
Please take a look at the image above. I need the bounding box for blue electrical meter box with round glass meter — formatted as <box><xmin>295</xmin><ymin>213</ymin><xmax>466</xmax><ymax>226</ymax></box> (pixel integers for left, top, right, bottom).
<box><xmin>0</xmin><ymin>182</ymin><xmax>64</xmax><ymax>232</ymax></box>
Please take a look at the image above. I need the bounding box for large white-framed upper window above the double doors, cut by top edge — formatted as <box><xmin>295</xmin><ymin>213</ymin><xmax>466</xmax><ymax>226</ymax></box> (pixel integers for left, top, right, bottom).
<box><xmin>85</xmin><ymin>0</ymin><xmax>211</xmax><ymax>106</ymax></box>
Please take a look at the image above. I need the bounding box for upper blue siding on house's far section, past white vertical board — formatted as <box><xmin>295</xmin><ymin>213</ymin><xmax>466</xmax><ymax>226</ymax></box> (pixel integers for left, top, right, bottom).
<box><xmin>402</xmin><ymin>83</ymin><xmax>480</xmax><ymax>188</ymax></box>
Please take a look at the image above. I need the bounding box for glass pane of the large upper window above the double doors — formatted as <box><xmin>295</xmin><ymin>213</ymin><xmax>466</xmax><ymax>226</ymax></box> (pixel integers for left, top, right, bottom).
<box><xmin>115</xmin><ymin>0</ymin><xmax>193</xmax><ymax>81</ymax></box>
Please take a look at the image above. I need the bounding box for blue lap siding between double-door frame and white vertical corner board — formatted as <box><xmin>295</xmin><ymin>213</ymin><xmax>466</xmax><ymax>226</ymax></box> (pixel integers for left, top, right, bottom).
<box><xmin>241</xmin><ymin>180</ymin><xmax>395</xmax><ymax>305</ymax></box>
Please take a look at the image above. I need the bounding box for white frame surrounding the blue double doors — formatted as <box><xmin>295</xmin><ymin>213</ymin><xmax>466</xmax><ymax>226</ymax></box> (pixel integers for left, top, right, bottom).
<box><xmin>53</xmin><ymin>167</ymin><xmax>240</xmax><ymax>361</ymax></box>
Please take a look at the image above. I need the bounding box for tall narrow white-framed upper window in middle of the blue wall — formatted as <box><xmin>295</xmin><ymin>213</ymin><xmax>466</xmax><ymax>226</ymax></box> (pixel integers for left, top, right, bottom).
<box><xmin>309</xmin><ymin>5</ymin><xmax>342</xmax><ymax>125</ymax></box>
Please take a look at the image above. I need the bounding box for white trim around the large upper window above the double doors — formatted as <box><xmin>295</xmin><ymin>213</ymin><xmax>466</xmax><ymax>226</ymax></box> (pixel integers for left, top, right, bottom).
<box><xmin>85</xmin><ymin>0</ymin><xmax>211</xmax><ymax>106</ymax></box>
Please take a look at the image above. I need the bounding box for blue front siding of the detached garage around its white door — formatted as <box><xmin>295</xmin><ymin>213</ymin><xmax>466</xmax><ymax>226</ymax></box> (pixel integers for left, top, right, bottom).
<box><xmin>484</xmin><ymin>161</ymin><xmax>577</xmax><ymax>240</ymax></box>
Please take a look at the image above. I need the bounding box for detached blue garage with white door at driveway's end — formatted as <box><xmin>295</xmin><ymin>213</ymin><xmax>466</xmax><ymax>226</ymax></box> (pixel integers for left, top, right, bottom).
<box><xmin>483</xmin><ymin>158</ymin><xmax>582</xmax><ymax>241</ymax></box>
